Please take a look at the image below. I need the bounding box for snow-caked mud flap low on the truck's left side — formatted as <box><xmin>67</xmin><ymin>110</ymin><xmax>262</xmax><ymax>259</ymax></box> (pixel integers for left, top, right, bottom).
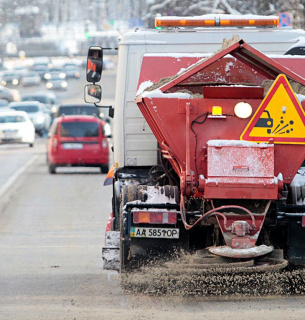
<box><xmin>102</xmin><ymin>231</ymin><xmax>120</xmax><ymax>271</ymax></box>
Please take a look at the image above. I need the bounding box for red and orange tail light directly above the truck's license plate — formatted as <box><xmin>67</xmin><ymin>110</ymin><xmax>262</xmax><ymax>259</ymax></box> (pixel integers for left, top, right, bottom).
<box><xmin>133</xmin><ymin>210</ymin><xmax>177</xmax><ymax>224</ymax></box>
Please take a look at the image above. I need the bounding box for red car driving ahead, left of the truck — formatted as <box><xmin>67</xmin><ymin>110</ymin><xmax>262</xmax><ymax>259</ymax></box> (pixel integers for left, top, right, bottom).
<box><xmin>47</xmin><ymin>115</ymin><xmax>109</xmax><ymax>174</ymax></box>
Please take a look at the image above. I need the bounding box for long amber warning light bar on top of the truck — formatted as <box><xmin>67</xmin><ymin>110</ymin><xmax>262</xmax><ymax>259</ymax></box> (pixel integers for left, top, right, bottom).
<box><xmin>155</xmin><ymin>16</ymin><xmax>279</xmax><ymax>28</ymax></box>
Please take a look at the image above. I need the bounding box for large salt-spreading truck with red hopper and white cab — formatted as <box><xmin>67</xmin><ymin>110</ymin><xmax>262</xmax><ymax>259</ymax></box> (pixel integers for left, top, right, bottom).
<box><xmin>85</xmin><ymin>15</ymin><xmax>305</xmax><ymax>278</ymax></box>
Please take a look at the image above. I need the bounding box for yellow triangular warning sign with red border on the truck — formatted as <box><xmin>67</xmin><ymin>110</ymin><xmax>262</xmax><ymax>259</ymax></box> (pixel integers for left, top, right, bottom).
<box><xmin>240</xmin><ymin>74</ymin><xmax>305</xmax><ymax>144</ymax></box>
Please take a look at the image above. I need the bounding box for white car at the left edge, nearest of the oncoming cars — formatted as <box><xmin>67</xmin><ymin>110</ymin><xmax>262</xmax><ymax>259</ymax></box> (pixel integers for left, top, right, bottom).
<box><xmin>0</xmin><ymin>110</ymin><xmax>35</xmax><ymax>147</ymax></box>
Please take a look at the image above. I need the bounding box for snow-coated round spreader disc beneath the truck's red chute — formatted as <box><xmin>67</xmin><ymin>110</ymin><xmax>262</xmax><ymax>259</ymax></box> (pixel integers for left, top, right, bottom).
<box><xmin>208</xmin><ymin>245</ymin><xmax>274</xmax><ymax>259</ymax></box>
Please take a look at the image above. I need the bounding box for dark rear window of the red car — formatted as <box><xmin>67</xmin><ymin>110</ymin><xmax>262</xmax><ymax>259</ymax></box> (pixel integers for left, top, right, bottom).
<box><xmin>60</xmin><ymin>122</ymin><xmax>98</xmax><ymax>138</ymax></box>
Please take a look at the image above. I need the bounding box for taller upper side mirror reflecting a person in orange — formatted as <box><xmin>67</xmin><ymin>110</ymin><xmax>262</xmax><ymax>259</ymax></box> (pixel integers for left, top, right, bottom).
<box><xmin>87</xmin><ymin>47</ymin><xmax>103</xmax><ymax>83</ymax></box>
